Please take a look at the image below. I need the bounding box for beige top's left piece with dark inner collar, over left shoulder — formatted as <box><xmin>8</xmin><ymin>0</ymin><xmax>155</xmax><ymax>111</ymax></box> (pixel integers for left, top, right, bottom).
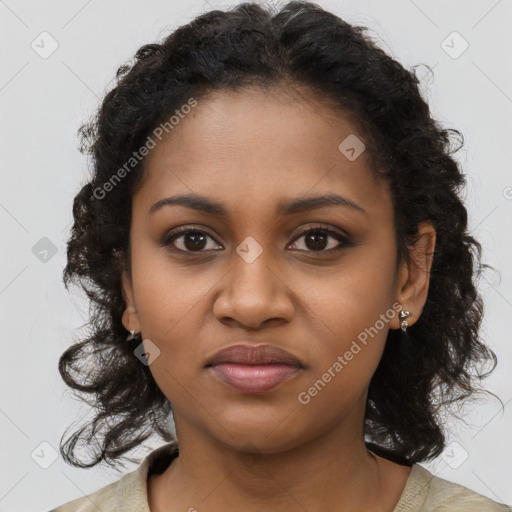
<box><xmin>50</xmin><ymin>442</ymin><xmax>178</xmax><ymax>512</ymax></box>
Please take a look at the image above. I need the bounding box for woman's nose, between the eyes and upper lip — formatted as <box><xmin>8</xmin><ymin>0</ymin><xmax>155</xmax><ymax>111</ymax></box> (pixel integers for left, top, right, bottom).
<box><xmin>213</xmin><ymin>245</ymin><xmax>295</xmax><ymax>329</ymax></box>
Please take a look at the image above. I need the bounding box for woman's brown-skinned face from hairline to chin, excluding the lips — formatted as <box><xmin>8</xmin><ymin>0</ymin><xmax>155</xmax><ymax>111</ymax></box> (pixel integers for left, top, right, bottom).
<box><xmin>123</xmin><ymin>85</ymin><xmax>412</xmax><ymax>453</ymax></box>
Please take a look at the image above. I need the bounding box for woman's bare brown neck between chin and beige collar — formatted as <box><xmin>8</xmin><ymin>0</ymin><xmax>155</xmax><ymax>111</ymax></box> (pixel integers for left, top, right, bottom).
<box><xmin>151</xmin><ymin>406</ymin><xmax>409</xmax><ymax>512</ymax></box>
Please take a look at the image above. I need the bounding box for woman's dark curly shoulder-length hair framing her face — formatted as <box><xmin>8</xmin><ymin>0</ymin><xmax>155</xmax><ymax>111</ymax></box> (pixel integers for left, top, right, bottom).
<box><xmin>59</xmin><ymin>1</ymin><xmax>496</xmax><ymax>467</ymax></box>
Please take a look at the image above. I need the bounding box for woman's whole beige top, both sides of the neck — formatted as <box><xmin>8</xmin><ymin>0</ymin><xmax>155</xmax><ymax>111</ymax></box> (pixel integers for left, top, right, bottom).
<box><xmin>50</xmin><ymin>442</ymin><xmax>512</xmax><ymax>512</ymax></box>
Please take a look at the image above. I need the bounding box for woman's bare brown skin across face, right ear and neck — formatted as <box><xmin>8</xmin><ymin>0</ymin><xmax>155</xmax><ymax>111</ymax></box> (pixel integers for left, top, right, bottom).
<box><xmin>123</xmin><ymin>87</ymin><xmax>435</xmax><ymax>512</ymax></box>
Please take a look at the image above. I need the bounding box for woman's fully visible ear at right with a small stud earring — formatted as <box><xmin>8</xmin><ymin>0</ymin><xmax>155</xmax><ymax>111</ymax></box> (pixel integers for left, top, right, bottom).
<box><xmin>389</xmin><ymin>221</ymin><xmax>436</xmax><ymax>329</ymax></box>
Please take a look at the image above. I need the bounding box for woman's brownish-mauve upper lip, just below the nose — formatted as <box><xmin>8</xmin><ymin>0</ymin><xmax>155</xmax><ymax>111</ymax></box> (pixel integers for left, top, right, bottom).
<box><xmin>206</xmin><ymin>343</ymin><xmax>302</xmax><ymax>367</ymax></box>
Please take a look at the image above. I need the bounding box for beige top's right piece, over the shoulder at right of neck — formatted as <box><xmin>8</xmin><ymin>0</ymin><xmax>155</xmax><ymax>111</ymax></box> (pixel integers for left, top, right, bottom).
<box><xmin>395</xmin><ymin>464</ymin><xmax>512</xmax><ymax>512</ymax></box>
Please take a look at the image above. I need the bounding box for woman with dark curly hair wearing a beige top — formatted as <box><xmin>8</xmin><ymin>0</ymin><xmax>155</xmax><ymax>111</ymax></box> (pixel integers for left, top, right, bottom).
<box><xmin>49</xmin><ymin>2</ymin><xmax>512</xmax><ymax>512</ymax></box>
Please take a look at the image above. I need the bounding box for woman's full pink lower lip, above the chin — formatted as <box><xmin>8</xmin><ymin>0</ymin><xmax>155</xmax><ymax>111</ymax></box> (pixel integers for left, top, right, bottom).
<box><xmin>210</xmin><ymin>363</ymin><xmax>300</xmax><ymax>393</ymax></box>
